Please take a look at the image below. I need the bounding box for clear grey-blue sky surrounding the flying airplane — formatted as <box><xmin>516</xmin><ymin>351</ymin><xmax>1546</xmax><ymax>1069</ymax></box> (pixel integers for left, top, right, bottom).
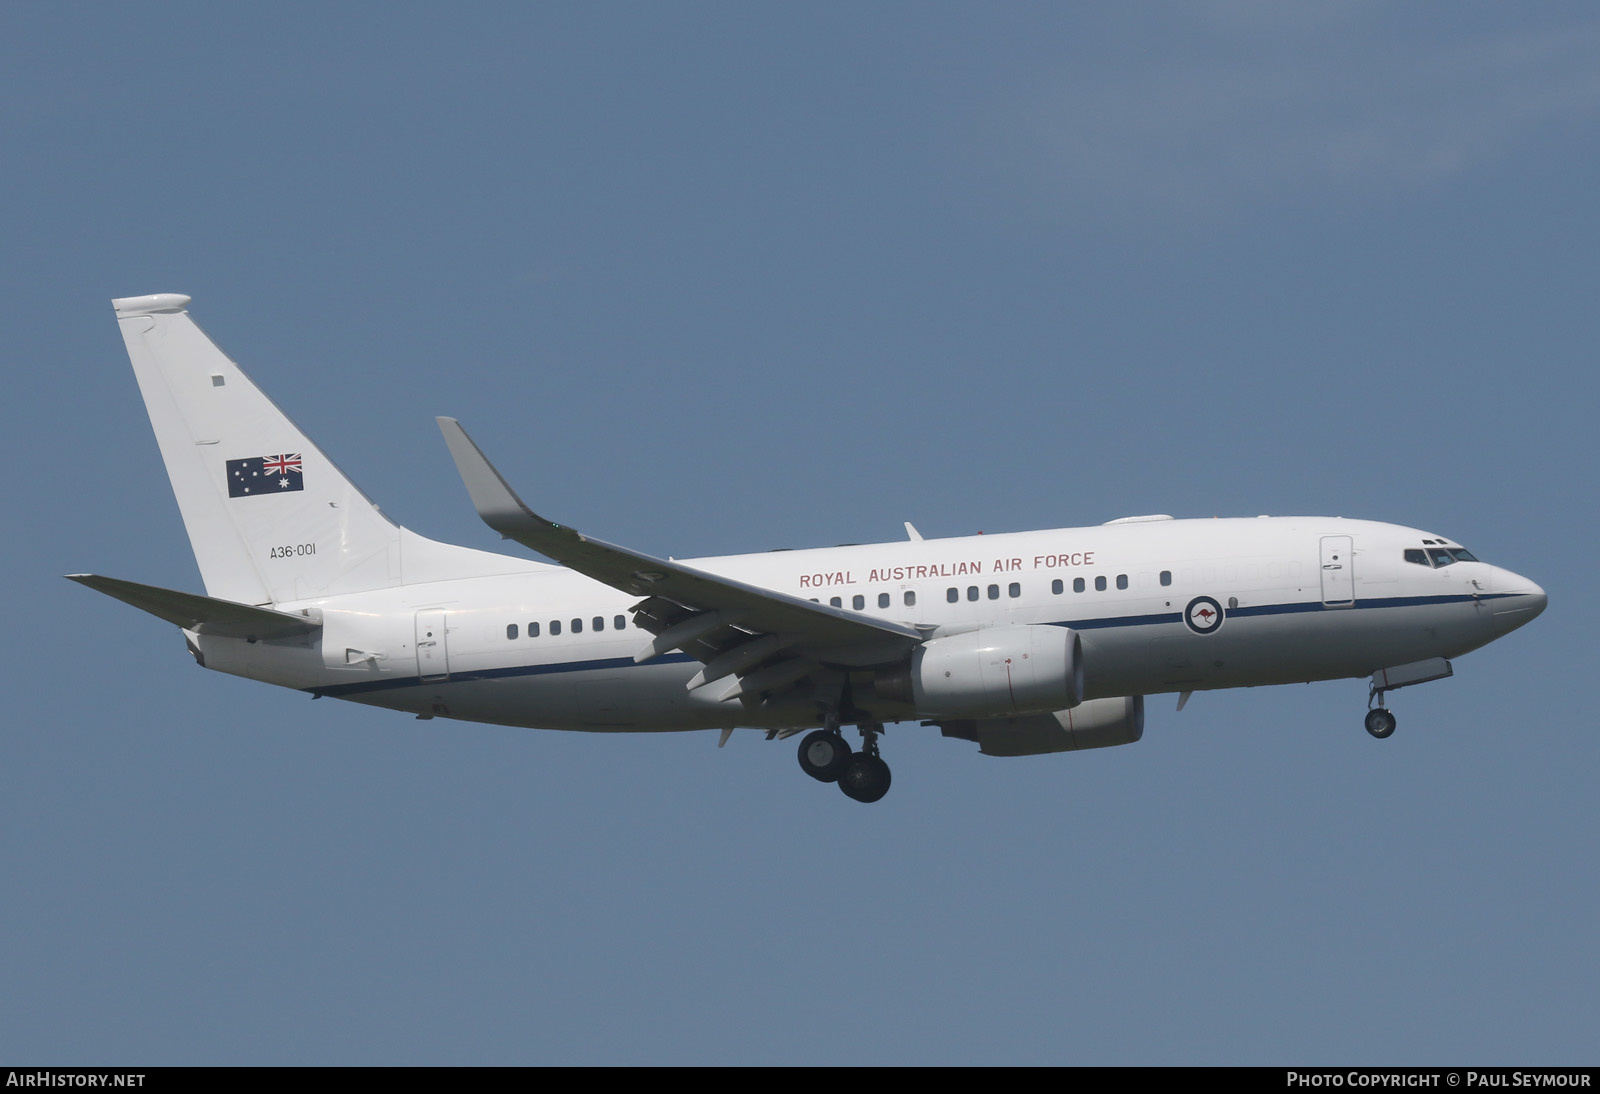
<box><xmin>0</xmin><ymin>2</ymin><xmax>1600</xmax><ymax>1064</ymax></box>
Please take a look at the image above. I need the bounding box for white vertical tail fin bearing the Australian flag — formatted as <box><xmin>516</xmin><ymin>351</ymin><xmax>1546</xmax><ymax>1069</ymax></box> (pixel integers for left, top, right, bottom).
<box><xmin>112</xmin><ymin>293</ymin><xmax>534</xmax><ymax>605</ymax></box>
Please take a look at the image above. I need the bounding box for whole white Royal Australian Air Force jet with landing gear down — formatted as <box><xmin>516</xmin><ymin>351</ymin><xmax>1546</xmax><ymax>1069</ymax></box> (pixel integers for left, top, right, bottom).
<box><xmin>72</xmin><ymin>293</ymin><xmax>1546</xmax><ymax>801</ymax></box>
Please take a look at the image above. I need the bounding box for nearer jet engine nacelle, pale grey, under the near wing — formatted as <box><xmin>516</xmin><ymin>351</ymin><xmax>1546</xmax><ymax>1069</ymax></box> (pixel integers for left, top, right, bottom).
<box><xmin>910</xmin><ymin>625</ymin><xmax>1083</xmax><ymax>718</ymax></box>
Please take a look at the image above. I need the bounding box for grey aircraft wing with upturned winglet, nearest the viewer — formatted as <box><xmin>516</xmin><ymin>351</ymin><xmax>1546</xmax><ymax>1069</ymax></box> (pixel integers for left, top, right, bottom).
<box><xmin>437</xmin><ymin>417</ymin><xmax>923</xmax><ymax>697</ymax></box>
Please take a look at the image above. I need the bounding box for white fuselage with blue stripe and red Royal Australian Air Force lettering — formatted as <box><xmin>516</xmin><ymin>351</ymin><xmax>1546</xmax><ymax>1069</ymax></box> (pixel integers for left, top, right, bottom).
<box><xmin>190</xmin><ymin>517</ymin><xmax>1544</xmax><ymax>731</ymax></box>
